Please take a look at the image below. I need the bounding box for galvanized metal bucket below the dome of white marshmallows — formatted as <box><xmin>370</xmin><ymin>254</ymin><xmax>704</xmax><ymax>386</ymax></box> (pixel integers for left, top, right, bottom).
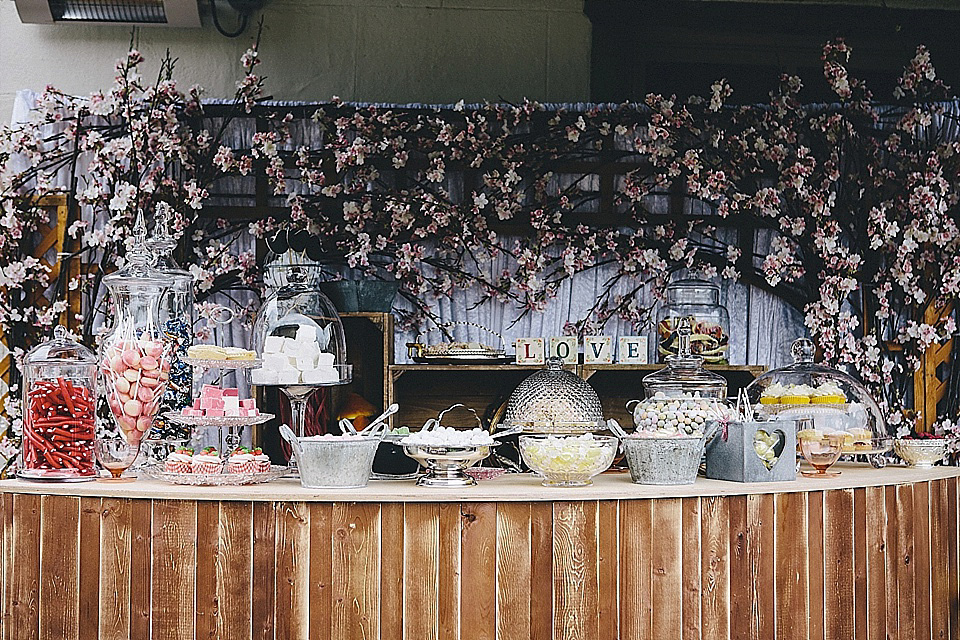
<box><xmin>280</xmin><ymin>425</ymin><xmax>380</xmax><ymax>489</ymax></box>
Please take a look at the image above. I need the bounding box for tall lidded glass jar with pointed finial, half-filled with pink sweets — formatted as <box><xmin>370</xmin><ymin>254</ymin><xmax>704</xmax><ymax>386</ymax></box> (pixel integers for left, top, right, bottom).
<box><xmin>100</xmin><ymin>213</ymin><xmax>173</xmax><ymax>445</ymax></box>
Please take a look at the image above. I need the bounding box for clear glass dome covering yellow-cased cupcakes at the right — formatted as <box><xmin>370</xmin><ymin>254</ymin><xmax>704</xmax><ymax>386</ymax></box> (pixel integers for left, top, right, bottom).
<box><xmin>747</xmin><ymin>338</ymin><xmax>892</xmax><ymax>456</ymax></box>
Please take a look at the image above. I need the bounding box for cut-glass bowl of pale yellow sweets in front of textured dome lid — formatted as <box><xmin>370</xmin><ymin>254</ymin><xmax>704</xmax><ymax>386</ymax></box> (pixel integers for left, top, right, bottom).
<box><xmin>520</xmin><ymin>434</ymin><xmax>618</xmax><ymax>487</ymax></box>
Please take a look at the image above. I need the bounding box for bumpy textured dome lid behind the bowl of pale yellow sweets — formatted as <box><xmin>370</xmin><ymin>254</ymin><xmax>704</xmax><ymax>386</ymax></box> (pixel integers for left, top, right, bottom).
<box><xmin>503</xmin><ymin>358</ymin><xmax>606</xmax><ymax>433</ymax></box>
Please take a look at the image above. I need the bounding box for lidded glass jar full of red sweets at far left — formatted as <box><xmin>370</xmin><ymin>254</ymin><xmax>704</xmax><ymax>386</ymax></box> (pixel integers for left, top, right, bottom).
<box><xmin>18</xmin><ymin>326</ymin><xmax>97</xmax><ymax>482</ymax></box>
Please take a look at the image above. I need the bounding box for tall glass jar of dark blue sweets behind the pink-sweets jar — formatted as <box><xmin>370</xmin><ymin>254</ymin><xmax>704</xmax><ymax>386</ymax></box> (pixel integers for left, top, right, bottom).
<box><xmin>147</xmin><ymin>204</ymin><xmax>194</xmax><ymax>440</ymax></box>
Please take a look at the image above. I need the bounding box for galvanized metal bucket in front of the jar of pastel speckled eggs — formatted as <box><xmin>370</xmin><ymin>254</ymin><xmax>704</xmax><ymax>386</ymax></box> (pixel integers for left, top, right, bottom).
<box><xmin>621</xmin><ymin>436</ymin><xmax>706</xmax><ymax>484</ymax></box>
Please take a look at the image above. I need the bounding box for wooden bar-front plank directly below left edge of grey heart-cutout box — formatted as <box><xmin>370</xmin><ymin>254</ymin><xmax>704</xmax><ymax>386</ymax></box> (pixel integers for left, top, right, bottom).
<box><xmin>700</xmin><ymin>496</ymin><xmax>730</xmax><ymax>640</ymax></box>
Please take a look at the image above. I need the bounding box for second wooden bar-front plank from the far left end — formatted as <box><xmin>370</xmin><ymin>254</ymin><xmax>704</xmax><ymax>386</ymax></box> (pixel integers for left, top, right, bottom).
<box><xmin>9</xmin><ymin>493</ymin><xmax>40</xmax><ymax>640</ymax></box>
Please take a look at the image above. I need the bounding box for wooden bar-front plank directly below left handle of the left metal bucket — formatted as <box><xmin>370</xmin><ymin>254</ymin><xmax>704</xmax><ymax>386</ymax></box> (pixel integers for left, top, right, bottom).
<box><xmin>276</xmin><ymin>502</ymin><xmax>310</xmax><ymax>640</ymax></box>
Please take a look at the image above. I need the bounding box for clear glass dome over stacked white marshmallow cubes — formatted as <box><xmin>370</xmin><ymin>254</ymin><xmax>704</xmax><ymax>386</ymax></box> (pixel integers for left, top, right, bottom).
<box><xmin>252</xmin><ymin>266</ymin><xmax>353</xmax><ymax>387</ymax></box>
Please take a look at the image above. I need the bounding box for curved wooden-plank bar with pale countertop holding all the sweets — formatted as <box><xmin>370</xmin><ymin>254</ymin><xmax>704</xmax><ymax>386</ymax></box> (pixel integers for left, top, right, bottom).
<box><xmin>0</xmin><ymin>468</ymin><xmax>960</xmax><ymax>640</ymax></box>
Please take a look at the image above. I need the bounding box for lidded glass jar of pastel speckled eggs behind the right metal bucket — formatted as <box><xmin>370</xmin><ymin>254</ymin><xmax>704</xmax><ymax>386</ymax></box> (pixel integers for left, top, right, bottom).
<box><xmin>628</xmin><ymin>318</ymin><xmax>729</xmax><ymax>437</ymax></box>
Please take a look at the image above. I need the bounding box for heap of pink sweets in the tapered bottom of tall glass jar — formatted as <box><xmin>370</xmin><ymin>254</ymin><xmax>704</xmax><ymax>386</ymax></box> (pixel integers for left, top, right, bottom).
<box><xmin>100</xmin><ymin>340</ymin><xmax>170</xmax><ymax>441</ymax></box>
